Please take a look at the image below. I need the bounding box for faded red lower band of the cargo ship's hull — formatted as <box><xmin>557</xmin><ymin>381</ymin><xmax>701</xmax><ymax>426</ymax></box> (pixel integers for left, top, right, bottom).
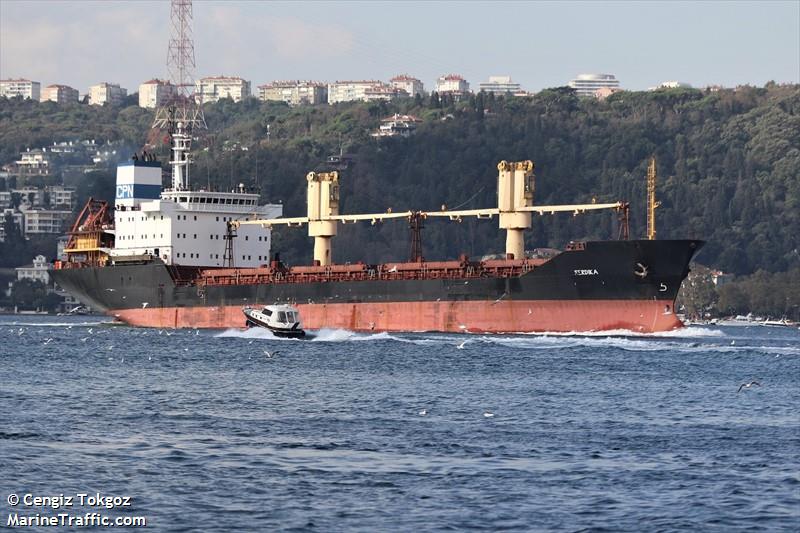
<box><xmin>109</xmin><ymin>300</ymin><xmax>683</xmax><ymax>333</ymax></box>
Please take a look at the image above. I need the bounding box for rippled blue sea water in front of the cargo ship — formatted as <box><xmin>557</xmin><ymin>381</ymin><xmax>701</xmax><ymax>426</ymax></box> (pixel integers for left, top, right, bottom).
<box><xmin>0</xmin><ymin>316</ymin><xmax>800</xmax><ymax>531</ymax></box>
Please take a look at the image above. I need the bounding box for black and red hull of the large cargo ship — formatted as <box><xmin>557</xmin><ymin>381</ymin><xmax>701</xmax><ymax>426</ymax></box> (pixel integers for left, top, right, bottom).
<box><xmin>52</xmin><ymin>240</ymin><xmax>703</xmax><ymax>333</ymax></box>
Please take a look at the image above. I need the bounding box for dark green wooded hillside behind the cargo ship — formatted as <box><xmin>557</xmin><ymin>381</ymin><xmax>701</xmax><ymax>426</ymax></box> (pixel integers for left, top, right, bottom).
<box><xmin>0</xmin><ymin>84</ymin><xmax>800</xmax><ymax>275</ymax></box>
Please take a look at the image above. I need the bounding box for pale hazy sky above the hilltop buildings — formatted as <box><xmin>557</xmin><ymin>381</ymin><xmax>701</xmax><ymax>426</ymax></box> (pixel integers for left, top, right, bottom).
<box><xmin>0</xmin><ymin>0</ymin><xmax>800</xmax><ymax>94</ymax></box>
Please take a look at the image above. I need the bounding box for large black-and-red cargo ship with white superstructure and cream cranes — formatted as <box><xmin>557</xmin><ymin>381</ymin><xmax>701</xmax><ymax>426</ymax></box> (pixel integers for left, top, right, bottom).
<box><xmin>52</xmin><ymin>124</ymin><xmax>703</xmax><ymax>333</ymax></box>
